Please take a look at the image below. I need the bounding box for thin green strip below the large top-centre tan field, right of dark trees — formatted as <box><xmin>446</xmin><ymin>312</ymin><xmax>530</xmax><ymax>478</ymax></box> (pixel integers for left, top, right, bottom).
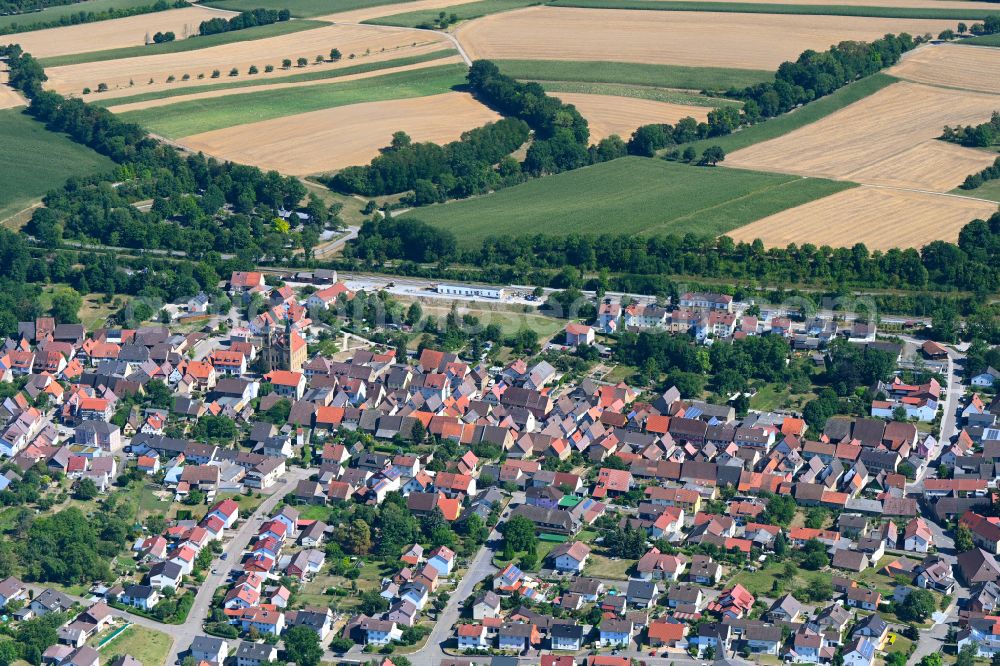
<box><xmin>494</xmin><ymin>60</ymin><xmax>774</xmax><ymax>90</ymax></box>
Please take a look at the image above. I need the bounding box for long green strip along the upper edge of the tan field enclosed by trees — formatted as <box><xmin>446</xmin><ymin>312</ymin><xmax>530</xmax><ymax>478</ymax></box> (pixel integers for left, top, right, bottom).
<box><xmin>121</xmin><ymin>64</ymin><xmax>466</xmax><ymax>138</ymax></box>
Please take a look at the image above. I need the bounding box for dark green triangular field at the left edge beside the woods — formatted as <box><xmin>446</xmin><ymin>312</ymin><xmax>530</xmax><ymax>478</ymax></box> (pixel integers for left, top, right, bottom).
<box><xmin>0</xmin><ymin>109</ymin><xmax>114</xmax><ymax>220</ymax></box>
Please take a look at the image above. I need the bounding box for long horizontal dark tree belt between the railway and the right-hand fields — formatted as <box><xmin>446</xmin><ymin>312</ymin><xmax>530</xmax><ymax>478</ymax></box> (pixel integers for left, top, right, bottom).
<box><xmin>345</xmin><ymin>213</ymin><xmax>1000</xmax><ymax>294</ymax></box>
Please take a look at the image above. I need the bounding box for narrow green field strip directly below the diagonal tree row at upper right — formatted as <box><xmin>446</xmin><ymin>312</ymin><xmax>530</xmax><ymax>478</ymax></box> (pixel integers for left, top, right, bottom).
<box><xmin>690</xmin><ymin>74</ymin><xmax>898</xmax><ymax>153</ymax></box>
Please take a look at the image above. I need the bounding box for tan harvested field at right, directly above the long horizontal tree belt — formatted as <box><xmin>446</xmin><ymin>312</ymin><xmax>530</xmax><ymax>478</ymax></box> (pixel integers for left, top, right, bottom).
<box><xmin>728</xmin><ymin>187</ymin><xmax>996</xmax><ymax>250</ymax></box>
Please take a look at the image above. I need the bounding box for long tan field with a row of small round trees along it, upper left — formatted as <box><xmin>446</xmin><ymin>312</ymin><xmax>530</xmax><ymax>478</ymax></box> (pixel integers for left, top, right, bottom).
<box><xmin>46</xmin><ymin>24</ymin><xmax>448</xmax><ymax>99</ymax></box>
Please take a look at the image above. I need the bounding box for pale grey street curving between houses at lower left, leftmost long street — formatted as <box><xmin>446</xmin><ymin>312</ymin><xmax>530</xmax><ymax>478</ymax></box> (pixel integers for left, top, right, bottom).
<box><xmin>166</xmin><ymin>467</ymin><xmax>312</xmax><ymax>664</ymax></box>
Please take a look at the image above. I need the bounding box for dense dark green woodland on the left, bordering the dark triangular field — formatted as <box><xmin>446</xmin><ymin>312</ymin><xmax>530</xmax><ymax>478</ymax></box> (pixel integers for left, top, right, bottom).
<box><xmin>0</xmin><ymin>45</ymin><xmax>330</xmax><ymax>262</ymax></box>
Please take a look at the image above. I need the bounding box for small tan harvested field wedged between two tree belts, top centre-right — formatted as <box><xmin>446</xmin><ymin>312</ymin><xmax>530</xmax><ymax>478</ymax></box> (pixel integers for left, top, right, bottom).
<box><xmin>552</xmin><ymin>92</ymin><xmax>711</xmax><ymax>141</ymax></box>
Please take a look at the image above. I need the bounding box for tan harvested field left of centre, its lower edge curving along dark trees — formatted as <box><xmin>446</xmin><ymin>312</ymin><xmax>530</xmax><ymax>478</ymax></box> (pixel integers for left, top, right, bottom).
<box><xmin>178</xmin><ymin>92</ymin><xmax>500</xmax><ymax>175</ymax></box>
